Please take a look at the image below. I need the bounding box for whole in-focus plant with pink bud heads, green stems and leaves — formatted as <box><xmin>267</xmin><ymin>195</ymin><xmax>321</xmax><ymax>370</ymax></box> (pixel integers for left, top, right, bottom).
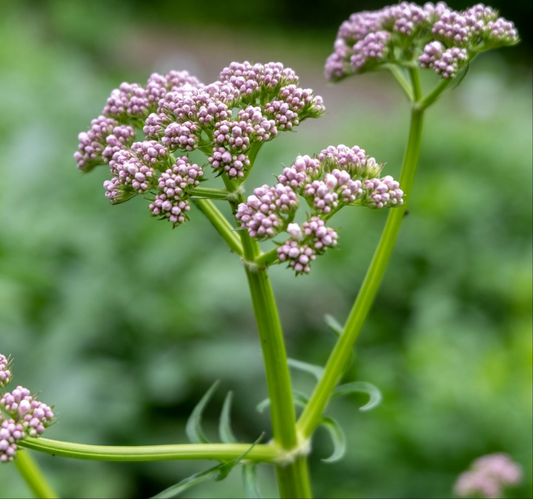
<box><xmin>0</xmin><ymin>2</ymin><xmax>518</xmax><ymax>498</ymax></box>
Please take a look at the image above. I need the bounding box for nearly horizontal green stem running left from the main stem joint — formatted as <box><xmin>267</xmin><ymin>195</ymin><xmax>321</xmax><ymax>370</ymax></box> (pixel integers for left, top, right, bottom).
<box><xmin>17</xmin><ymin>437</ymin><xmax>281</xmax><ymax>462</ymax></box>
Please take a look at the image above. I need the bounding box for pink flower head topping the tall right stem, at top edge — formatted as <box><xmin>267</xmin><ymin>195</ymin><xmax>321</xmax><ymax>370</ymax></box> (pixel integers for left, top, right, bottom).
<box><xmin>325</xmin><ymin>2</ymin><xmax>518</xmax><ymax>81</ymax></box>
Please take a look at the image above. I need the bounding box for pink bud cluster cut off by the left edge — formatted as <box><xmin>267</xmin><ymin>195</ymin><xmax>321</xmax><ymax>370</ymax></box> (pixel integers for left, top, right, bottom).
<box><xmin>0</xmin><ymin>354</ymin><xmax>54</xmax><ymax>463</ymax></box>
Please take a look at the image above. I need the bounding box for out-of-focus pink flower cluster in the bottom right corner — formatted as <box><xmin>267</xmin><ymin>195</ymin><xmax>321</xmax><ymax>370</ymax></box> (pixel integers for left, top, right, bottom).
<box><xmin>455</xmin><ymin>453</ymin><xmax>522</xmax><ymax>498</ymax></box>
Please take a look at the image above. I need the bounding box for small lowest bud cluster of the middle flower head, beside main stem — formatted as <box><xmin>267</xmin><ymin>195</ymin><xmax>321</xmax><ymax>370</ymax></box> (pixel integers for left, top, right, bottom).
<box><xmin>277</xmin><ymin>217</ymin><xmax>337</xmax><ymax>275</ymax></box>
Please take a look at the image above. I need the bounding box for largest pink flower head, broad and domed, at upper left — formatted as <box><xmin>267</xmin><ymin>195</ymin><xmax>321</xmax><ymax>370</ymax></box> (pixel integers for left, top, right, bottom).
<box><xmin>74</xmin><ymin>62</ymin><xmax>324</xmax><ymax>226</ymax></box>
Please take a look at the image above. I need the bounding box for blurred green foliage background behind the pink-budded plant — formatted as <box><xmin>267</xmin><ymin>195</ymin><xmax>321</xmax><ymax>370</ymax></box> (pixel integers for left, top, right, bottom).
<box><xmin>0</xmin><ymin>0</ymin><xmax>532</xmax><ymax>498</ymax></box>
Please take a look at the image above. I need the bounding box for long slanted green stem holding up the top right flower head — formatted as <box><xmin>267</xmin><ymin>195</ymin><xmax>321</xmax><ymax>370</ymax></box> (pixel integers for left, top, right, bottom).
<box><xmin>298</xmin><ymin>105</ymin><xmax>423</xmax><ymax>437</ymax></box>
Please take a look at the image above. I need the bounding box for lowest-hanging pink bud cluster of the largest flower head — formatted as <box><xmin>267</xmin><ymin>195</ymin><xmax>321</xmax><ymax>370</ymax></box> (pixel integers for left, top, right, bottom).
<box><xmin>149</xmin><ymin>157</ymin><xmax>204</xmax><ymax>227</ymax></box>
